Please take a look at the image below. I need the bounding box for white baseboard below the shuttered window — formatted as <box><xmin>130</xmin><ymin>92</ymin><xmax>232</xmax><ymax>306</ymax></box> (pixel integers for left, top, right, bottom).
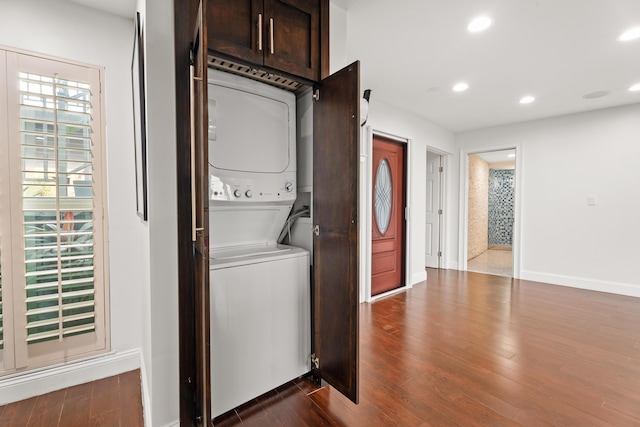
<box><xmin>0</xmin><ymin>349</ymin><xmax>141</xmax><ymax>405</ymax></box>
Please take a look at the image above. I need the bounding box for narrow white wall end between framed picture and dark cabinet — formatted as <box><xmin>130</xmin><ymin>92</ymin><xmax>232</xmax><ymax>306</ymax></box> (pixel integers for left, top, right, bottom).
<box><xmin>138</xmin><ymin>0</ymin><xmax>180</xmax><ymax>426</ymax></box>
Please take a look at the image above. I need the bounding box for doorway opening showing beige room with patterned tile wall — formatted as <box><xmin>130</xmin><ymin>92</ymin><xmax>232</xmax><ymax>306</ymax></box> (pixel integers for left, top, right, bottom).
<box><xmin>460</xmin><ymin>147</ymin><xmax>519</xmax><ymax>278</ymax></box>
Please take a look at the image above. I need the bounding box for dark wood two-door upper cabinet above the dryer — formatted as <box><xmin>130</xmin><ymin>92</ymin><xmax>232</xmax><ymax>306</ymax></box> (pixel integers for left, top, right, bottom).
<box><xmin>207</xmin><ymin>0</ymin><xmax>329</xmax><ymax>82</ymax></box>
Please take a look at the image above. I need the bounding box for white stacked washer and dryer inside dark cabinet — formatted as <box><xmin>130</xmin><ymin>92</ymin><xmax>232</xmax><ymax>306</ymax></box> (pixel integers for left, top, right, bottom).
<box><xmin>208</xmin><ymin>69</ymin><xmax>311</xmax><ymax>417</ymax></box>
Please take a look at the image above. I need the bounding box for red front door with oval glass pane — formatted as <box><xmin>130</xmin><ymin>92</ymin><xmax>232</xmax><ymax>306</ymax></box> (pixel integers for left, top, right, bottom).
<box><xmin>371</xmin><ymin>135</ymin><xmax>405</xmax><ymax>295</ymax></box>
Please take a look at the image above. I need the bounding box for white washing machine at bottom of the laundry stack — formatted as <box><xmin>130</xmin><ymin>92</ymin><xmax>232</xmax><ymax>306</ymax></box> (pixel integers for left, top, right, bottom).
<box><xmin>211</xmin><ymin>245</ymin><xmax>311</xmax><ymax>417</ymax></box>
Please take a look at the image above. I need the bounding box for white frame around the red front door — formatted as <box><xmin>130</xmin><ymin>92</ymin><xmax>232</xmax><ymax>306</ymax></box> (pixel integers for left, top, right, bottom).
<box><xmin>360</xmin><ymin>125</ymin><xmax>413</xmax><ymax>302</ymax></box>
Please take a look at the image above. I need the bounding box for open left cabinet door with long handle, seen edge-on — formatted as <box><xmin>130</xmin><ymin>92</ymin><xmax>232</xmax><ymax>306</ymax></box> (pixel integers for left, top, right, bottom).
<box><xmin>190</xmin><ymin>1</ymin><xmax>211</xmax><ymax>425</ymax></box>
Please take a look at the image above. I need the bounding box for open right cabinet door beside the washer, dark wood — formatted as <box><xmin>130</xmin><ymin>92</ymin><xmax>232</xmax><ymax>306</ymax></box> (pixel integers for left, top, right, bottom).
<box><xmin>312</xmin><ymin>62</ymin><xmax>360</xmax><ymax>403</ymax></box>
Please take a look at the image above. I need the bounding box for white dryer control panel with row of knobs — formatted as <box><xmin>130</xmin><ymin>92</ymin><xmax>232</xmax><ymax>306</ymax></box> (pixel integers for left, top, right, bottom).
<box><xmin>209</xmin><ymin>172</ymin><xmax>297</xmax><ymax>202</ymax></box>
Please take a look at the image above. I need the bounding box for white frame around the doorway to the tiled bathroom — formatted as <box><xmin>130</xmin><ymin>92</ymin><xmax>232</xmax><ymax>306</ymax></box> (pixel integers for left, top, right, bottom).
<box><xmin>458</xmin><ymin>142</ymin><xmax>524</xmax><ymax>279</ymax></box>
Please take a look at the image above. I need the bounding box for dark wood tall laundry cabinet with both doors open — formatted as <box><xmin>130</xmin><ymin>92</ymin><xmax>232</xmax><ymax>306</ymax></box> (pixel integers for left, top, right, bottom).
<box><xmin>174</xmin><ymin>0</ymin><xmax>360</xmax><ymax>426</ymax></box>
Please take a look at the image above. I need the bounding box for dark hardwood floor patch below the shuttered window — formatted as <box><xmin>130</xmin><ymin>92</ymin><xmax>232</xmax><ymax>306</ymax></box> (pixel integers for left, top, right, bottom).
<box><xmin>0</xmin><ymin>369</ymin><xmax>144</xmax><ymax>427</ymax></box>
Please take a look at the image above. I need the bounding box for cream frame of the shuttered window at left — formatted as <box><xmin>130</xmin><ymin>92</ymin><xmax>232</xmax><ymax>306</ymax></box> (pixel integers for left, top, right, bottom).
<box><xmin>0</xmin><ymin>46</ymin><xmax>111</xmax><ymax>376</ymax></box>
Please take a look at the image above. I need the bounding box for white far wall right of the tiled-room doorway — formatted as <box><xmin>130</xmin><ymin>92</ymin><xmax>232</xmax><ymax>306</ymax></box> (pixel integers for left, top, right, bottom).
<box><xmin>456</xmin><ymin>104</ymin><xmax>640</xmax><ymax>296</ymax></box>
